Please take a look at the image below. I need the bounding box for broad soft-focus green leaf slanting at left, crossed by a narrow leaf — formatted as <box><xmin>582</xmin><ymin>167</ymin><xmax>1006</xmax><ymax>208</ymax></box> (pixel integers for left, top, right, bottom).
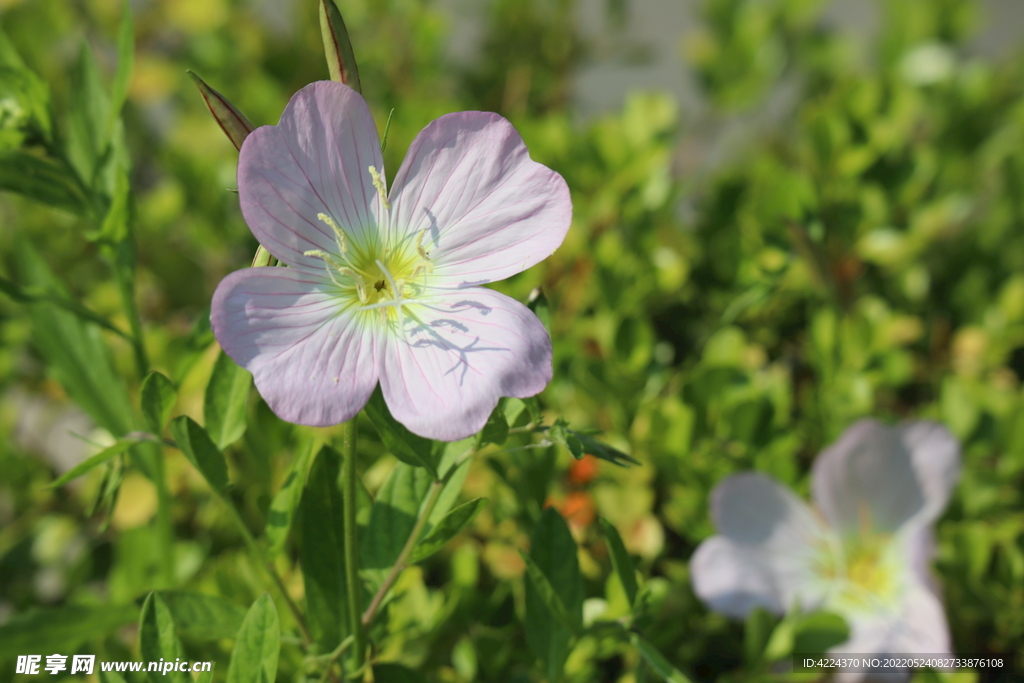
<box><xmin>13</xmin><ymin>237</ymin><xmax>134</xmax><ymax>436</ymax></box>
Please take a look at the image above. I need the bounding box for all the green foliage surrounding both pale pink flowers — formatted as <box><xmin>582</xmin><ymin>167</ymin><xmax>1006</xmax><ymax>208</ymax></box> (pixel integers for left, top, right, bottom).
<box><xmin>0</xmin><ymin>0</ymin><xmax>1024</xmax><ymax>683</ymax></box>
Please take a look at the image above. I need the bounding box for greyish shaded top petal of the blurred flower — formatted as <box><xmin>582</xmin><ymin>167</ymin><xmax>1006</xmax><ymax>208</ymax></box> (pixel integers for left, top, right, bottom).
<box><xmin>812</xmin><ymin>420</ymin><xmax>926</xmax><ymax>535</ymax></box>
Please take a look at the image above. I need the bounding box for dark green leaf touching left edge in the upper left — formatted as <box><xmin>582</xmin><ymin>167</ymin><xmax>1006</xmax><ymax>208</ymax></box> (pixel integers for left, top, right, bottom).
<box><xmin>0</xmin><ymin>150</ymin><xmax>89</xmax><ymax>216</ymax></box>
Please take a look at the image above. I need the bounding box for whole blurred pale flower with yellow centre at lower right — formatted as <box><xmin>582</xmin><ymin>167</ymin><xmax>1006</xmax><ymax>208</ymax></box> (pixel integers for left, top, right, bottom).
<box><xmin>691</xmin><ymin>420</ymin><xmax>959</xmax><ymax>680</ymax></box>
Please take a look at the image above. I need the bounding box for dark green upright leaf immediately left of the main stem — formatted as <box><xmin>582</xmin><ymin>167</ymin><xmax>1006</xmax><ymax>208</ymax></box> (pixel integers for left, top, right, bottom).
<box><xmin>299</xmin><ymin>446</ymin><xmax>348</xmax><ymax>652</ymax></box>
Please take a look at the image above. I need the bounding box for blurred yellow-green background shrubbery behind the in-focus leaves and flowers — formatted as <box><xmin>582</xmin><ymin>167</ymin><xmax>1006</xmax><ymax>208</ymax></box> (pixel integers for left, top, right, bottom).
<box><xmin>0</xmin><ymin>0</ymin><xmax>1024</xmax><ymax>683</ymax></box>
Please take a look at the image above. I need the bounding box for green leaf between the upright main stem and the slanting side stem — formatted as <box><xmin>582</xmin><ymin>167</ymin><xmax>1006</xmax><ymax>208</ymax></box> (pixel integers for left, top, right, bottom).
<box><xmin>359</xmin><ymin>462</ymin><xmax>432</xmax><ymax>583</ymax></box>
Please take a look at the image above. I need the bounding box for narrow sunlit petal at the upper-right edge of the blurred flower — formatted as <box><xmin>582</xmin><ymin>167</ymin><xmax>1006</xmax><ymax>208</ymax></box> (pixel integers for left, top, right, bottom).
<box><xmin>898</xmin><ymin>420</ymin><xmax>961</xmax><ymax>523</ymax></box>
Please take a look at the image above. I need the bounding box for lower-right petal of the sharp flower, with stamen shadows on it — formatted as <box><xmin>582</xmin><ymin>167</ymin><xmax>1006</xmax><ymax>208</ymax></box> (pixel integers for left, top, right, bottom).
<box><xmin>381</xmin><ymin>288</ymin><xmax>551</xmax><ymax>441</ymax></box>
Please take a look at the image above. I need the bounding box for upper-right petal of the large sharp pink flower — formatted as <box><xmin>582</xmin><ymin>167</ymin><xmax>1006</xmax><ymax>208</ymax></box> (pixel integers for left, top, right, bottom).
<box><xmin>391</xmin><ymin>112</ymin><xmax>572</xmax><ymax>287</ymax></box>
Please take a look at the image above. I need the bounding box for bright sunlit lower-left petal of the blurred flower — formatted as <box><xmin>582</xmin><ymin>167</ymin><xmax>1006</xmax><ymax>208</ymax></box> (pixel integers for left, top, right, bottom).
<box><xmin>690</xmin><ymin>536</ymin><xmax>785</xmax><ymax>618</ymax></box>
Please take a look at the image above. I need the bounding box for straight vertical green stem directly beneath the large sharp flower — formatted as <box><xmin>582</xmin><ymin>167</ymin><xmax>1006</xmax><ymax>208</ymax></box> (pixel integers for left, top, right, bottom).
<box><xmin>341</xmin><ymin>418</ymin><xmax>367</xmax><ymax>672</ymax></box>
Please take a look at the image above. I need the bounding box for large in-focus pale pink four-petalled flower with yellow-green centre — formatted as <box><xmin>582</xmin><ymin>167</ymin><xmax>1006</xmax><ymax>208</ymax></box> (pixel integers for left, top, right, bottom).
<box><xmin>211</xmin><ymin>81</ymin><xmax>572</xmax><ymax>440</ymax></box>
